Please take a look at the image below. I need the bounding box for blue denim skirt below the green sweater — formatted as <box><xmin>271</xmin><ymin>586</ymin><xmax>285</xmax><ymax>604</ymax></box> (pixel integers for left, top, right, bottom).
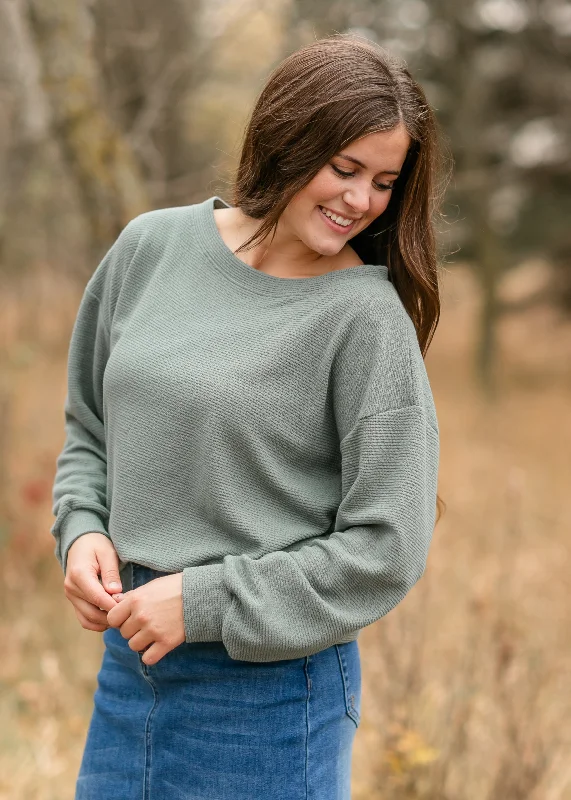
<box><xmin>75</xmin><ymin>564</ymin><xmax>361</xmax><ymax>800</ymax></box>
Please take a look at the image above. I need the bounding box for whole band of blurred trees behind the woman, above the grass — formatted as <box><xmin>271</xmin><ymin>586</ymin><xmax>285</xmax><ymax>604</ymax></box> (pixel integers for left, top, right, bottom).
<box><xmin>0</xmin><ymin>0</ymin><xmax>571</xmax><ymax>360</ymax></box>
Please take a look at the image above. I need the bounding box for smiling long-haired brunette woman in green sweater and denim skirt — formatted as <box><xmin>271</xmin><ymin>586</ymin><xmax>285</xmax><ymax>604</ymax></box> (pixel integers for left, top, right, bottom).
<box><xmin>52</xmin><ymin>34</ymin><xmax>452</xmax><ymax>800</ymax></box>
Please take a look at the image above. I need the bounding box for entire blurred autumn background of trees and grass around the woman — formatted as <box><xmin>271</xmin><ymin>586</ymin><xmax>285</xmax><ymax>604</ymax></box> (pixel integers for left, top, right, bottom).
<box><xmin>0</xmin><ymin>0</ymin><xmax>571</xmax><ymax>800</ymax></box>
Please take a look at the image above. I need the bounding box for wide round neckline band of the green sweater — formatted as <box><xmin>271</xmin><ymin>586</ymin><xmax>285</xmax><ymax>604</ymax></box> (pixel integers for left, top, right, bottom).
<box><xmin>195</xmin><ymin>195</ymin><xmax>388</xmax><ymax>296</ymax></box>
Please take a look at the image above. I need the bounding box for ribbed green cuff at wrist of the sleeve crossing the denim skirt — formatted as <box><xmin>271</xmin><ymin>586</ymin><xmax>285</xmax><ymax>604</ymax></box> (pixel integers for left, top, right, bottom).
<box><xmin>182</xmin><ymin>564</ymin><xmax>232</xmax><ymax>642</ymax></box>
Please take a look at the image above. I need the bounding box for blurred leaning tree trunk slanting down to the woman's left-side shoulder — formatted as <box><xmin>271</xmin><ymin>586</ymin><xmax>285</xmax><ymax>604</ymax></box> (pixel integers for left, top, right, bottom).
<box><xmin>27</xmin><ymin>0</ymin><xmax>148</xmax><ymax>260</ymax></box>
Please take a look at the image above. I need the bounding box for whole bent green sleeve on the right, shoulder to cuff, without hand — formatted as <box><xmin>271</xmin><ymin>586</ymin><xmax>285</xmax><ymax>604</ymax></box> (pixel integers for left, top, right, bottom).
<box><xmin>183</xmin><ymin>293</ymin><xmax>439</xmax><ymax>661</ymax></box>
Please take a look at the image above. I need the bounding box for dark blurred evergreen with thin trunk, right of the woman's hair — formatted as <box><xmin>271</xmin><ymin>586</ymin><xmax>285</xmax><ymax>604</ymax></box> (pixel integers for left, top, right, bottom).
<box><xmin>292</xmin><ymin>0</ymin><xmax>571</xmax><ymax>394</ymax></box>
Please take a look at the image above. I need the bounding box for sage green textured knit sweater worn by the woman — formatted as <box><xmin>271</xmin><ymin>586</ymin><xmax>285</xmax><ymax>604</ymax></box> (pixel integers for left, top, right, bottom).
<box><xmin>51</xmin><ymin>196</ymin><xmax>439</xmax><ymax>661</ymax></box>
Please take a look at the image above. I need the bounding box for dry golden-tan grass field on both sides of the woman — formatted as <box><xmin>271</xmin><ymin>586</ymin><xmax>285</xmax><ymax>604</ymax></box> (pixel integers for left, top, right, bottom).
<box><xmin>0</xmin><ymin>266</ymin><xmax>571</xmax><ymax>800</ymax></box>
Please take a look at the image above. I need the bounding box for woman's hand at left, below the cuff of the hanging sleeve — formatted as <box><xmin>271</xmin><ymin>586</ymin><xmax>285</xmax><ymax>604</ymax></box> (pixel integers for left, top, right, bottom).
<box><xmin>63</xmin><ymin>532</ymin><xmax>121</xmax><ymax>632</ymax></box>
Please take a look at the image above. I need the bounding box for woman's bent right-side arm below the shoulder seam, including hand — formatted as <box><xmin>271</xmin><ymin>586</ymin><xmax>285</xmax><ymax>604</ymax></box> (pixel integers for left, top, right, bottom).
<box><xmin>107</xmin><ymin>406</ymin><xmax>438</xmax><ymax>664</ymax></box>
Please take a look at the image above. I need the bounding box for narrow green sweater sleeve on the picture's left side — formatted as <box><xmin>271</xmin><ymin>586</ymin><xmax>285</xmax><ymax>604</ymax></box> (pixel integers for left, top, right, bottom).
<box><xmin>51</xmin><ymin>218</ymin><xmax>144</xmax><ymax>573</ymax></box>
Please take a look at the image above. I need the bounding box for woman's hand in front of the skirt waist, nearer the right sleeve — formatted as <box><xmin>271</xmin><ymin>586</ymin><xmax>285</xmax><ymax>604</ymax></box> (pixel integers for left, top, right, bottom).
<box><xmin>107</xmin><ymin>572</ymin><xmax>185</xmax><ymax>664</ymax></box>
